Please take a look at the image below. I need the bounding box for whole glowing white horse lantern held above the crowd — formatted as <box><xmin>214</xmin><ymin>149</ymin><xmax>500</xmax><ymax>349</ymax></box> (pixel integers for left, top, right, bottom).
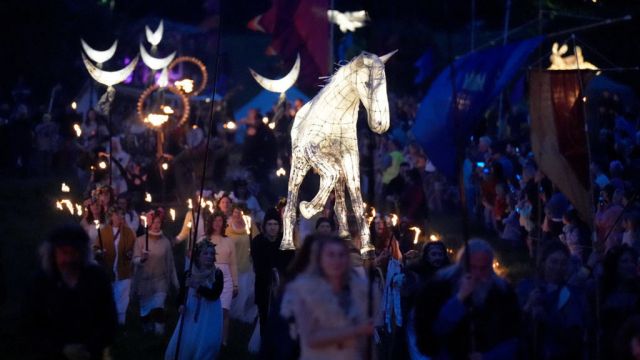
<box><xmin>280</xmin><ymin>50</ymin><xmax>397</xmax><ymax>252</ymax></box>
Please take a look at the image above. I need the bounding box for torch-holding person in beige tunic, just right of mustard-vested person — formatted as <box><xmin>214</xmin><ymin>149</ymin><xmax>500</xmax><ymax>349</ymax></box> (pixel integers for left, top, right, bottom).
<box><xmin>133</xmin><ymin>209</ymin><xmax>179</xmax><ymax>335</ymax></box>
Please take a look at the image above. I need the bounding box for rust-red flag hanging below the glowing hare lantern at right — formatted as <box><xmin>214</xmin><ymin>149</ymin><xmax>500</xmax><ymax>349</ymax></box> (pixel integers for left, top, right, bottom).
<box><xmin>529</xmin><ymin>70</ymin><xmax>594</xmax><ymax>224</ymax></box>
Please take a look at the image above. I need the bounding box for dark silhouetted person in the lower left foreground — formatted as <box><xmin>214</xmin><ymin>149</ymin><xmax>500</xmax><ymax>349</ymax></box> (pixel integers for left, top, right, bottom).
<box><xmin>25</xmin><ymin>225</ymin><xmax>118</xmax><ymax>360</ymax></box>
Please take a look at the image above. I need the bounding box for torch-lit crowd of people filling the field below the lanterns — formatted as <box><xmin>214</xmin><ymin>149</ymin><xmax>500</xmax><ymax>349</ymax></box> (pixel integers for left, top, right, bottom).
<box><xmin>0</xmin><ymin>71</ymin><xmax>640</xmax><ymax>359</ymax></box>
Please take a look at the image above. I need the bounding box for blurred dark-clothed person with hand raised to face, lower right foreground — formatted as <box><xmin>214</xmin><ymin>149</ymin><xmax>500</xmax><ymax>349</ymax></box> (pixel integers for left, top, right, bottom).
<box><xmin>415</xmin><ymin>239</ymin><xmax>520</xmax><ymax>359</ymax></box>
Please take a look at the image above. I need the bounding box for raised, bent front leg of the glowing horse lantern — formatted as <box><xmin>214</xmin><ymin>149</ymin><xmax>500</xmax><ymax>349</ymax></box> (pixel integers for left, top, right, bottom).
<box><xmin>300</xmin><ymin>148</ymin><xmax>340</xmax><ymax>219</ymax></box>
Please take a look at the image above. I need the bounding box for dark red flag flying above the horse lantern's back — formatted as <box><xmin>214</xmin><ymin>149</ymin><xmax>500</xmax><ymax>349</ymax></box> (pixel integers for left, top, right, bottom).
<box><xmin>247</xmin><ymin>0</ymin><xmax>331</xmax><ymax>89</ymax></box>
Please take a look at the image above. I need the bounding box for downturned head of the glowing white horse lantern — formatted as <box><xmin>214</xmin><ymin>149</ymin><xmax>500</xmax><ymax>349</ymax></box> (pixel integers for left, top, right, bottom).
<box><xmin>353</xmin><ymin>50</ymin><xmax>398</xmax><ymax>134</ymax></box>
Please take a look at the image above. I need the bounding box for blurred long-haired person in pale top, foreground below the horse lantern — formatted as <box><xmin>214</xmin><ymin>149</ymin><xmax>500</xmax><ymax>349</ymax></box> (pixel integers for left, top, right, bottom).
<box><xmin>281</xmin><ymin>237</ymin><xmax>373</xmax><ymax>360</ymax></box>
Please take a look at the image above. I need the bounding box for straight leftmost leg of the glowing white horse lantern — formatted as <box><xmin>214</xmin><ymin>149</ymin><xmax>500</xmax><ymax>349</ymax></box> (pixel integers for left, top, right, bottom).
<box><xmin>280</xmin><ymin>152</ymin><xmax>310</xmax><ymax>250</ymax></box>
